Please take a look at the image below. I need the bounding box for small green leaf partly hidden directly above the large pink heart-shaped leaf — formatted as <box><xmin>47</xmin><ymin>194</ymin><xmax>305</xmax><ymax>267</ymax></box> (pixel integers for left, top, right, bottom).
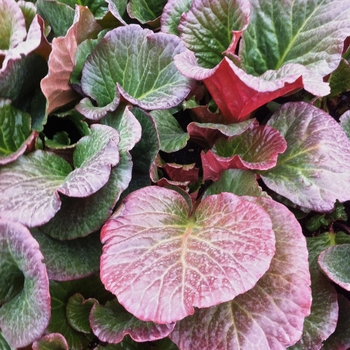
<box><xmin>203</xmin><ymin>169</ymin><xmax>267</xmax><ymax>198</ymax></box>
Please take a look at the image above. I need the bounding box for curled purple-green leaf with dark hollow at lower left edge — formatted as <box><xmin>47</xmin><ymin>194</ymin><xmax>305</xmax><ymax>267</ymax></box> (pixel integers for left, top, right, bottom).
<box><xmin>0</xmin><ymin>219</ymin><xmax>51</xmax><ymax>348</ymax></box>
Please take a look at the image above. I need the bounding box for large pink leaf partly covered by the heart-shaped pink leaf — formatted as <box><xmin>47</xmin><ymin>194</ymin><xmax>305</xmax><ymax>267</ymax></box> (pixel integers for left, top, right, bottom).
<box><xmin>170</xmin><ymin>197</ymin><xmax>311</xmax><ymax>350</ymax></box>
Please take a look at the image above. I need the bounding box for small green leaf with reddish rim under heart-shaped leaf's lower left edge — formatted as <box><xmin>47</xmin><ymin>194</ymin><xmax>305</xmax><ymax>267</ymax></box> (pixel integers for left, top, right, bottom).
<box><xmin>90</xmin><ymin>299</ymin><xmax>175</xmax><ymax>343</ymax></box>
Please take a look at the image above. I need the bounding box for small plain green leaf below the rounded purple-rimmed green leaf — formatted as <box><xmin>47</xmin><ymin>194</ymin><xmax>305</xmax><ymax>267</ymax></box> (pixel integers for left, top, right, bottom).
<box><xmin>150</xmin><ymin>110</ymin><xmax>190</xmax><ymax>153</ymax></box>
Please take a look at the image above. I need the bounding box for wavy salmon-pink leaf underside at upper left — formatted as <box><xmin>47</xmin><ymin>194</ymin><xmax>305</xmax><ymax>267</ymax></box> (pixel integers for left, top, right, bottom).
<box><xmin>41</xmin><ymin>6</ymin><xmax>101</xmax><ymax>114</ymax></box>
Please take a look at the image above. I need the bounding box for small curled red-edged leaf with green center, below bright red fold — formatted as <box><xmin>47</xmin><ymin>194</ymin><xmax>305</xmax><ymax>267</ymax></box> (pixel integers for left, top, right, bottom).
<box><xmin>201</xmin><ymin>123</ymin><xmax>287</xmax><ymax>181</ymax></box>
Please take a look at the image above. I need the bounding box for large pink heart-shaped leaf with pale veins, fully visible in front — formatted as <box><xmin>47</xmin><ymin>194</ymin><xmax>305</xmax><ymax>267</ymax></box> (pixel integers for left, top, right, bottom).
<box><xmin>101</xmin><ymin>186</ymin><xmax>275</xmax><ymax>324</ymax></box>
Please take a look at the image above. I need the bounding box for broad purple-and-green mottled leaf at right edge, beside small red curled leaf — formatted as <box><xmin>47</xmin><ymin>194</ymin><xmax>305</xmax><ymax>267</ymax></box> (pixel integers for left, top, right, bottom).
<box><xmin>261</xmin><ymin>102</ymin><xmax>350</xmax><ymax>212</ymax></box>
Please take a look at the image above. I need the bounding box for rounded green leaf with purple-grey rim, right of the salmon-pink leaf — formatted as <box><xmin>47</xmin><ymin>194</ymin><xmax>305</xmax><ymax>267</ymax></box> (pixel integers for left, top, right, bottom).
<box><xmin>77</xmin><ymin>25</ymin><xmax>191</xmax><ymax>119</ymax></box>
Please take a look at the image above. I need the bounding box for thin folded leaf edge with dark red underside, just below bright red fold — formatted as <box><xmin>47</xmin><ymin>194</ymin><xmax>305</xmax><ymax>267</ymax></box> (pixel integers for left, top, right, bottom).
<box><xmin>187</xmin><ymin>119</ymin><xmax>256</xmax><ymax>148</ymax></box>
